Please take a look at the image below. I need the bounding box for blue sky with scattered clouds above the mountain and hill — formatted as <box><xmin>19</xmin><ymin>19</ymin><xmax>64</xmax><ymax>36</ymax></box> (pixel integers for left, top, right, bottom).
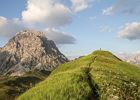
<box><xmin>0</xmin><ymin>0</ymin><xmax>140</xmax><ymax>58</ymax></box>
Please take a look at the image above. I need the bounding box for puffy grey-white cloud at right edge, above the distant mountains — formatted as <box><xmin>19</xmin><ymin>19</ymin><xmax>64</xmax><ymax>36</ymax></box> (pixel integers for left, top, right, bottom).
<box><xmin>118</xmin><ymin>22</ymin><xmax>140</xmax><ymax>40</ymax></box>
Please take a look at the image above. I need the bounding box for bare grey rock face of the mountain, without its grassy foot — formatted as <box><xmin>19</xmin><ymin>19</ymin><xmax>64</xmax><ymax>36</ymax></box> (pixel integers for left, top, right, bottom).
<box><xmin>0</xmin><ymin>30</ymin><xmax>68</xmax><ymax>76</ymax></box>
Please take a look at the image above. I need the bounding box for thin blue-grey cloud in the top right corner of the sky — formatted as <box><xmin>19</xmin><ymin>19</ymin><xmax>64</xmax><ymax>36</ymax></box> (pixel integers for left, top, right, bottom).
<box><xmin>103</xmin><ymin>0</ymin><xmax>140</xmax><ymax>15</ymax></box>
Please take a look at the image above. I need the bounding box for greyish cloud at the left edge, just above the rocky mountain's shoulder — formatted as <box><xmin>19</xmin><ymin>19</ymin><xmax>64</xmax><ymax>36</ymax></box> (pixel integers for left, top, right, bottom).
<box><xmin>0</xmin><ymin>16</ymin><xmax>24</xmax><ymax>37</ymax></box>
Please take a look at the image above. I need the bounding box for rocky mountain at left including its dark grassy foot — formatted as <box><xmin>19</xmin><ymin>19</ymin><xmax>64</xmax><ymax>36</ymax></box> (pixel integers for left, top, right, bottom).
<box><xmin>0</xmin><ymin>30</ymin><xmax>68</xmax><ymax>100</ymax></box>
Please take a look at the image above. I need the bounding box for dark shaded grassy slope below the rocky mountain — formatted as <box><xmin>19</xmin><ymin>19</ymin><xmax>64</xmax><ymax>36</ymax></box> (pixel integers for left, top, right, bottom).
<box><xmin>0</xmin><ymin>71</ymin><xmax>49</xmax><ymax>100</ymax></box>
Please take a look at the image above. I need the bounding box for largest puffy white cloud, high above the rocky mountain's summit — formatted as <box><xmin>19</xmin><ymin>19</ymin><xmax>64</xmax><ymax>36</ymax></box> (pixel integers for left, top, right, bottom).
<box><xmin>22</xmin><ymin>0</ymin><xmax>72</xmax><ymax>27</ymax></box>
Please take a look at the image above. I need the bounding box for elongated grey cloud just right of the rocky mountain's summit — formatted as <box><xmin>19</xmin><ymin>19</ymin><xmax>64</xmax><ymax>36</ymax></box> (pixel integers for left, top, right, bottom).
<box><xmin>44</xmin><ymin>28</ymin><xmax>76</xmax><ymax>44</ymax></box>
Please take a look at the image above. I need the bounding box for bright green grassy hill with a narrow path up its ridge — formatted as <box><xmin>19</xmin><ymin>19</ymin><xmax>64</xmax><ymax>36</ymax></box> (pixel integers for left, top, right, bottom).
<box><xmin>18</xmin><ymin>51</ymin><xmax>140</xmax><ymax>100</ymax></box>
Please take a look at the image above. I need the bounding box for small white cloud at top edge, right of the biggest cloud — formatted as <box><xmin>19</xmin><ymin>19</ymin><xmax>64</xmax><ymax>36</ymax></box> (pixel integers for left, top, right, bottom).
<box><xmin>71</xmin><ymin>0</ymin><xmax>90</xmax><ymax>12</ymax></box>
